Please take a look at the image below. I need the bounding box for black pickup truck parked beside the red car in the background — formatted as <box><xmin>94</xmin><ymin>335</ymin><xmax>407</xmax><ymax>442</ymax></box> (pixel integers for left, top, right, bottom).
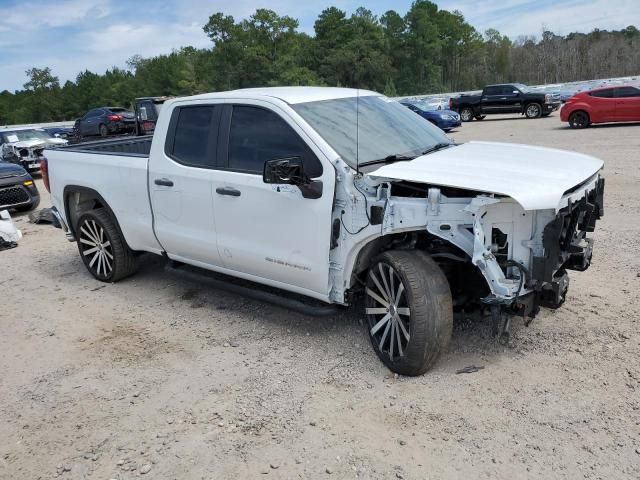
<box><xmin>449</xmin><ymin>83</ymin><xmax>561</xmax><ymax>122</ymax></box>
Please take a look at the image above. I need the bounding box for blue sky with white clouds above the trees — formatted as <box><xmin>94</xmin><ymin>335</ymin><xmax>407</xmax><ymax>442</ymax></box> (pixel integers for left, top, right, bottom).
<box><xmin>0</xmin><ymin>0</ymin><xmax>640</xmax><ymax>91</ymax></box>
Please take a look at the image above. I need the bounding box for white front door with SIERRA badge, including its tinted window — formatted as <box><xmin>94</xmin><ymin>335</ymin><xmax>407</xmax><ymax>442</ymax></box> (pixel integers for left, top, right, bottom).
<box><xmin>212</xmin><ymin>102</ymin><xmax>335</xmax><ymax>298</ymax></box>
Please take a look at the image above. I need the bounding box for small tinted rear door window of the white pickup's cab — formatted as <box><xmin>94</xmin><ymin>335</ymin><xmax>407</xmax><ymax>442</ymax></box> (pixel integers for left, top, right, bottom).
<box><xmin>167</xmin><ymin>105</ymin><xmax>217</xmax><ymax>167</ymax></box>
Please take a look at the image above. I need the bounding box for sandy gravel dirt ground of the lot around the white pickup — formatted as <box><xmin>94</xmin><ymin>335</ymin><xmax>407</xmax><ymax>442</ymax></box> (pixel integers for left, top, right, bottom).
<box><xmin>0</xmin><ymin>113</ymin><xmax>640</xmax><ymax>480</ymax></box>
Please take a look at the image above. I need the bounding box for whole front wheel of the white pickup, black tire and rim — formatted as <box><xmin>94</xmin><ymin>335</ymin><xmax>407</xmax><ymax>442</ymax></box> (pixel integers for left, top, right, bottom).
<box><xmin>365</xmin><ymin>250</ymin><xmax>453</xmax><ymax>376</ymax></box>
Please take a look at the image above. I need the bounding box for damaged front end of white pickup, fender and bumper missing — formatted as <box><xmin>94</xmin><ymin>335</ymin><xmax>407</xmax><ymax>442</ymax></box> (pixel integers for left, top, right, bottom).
<box><xmin>332</xmin><ymin>141</ymin><xmax>604</xmax><ymax>335</ymax></box>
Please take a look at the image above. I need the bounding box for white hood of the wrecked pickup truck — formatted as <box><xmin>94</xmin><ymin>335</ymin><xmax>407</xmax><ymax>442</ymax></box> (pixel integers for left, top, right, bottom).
<box><xmin>369</xmin><ymin>142</ymin><xmax>604</xmax><ymax>210</ymax></box>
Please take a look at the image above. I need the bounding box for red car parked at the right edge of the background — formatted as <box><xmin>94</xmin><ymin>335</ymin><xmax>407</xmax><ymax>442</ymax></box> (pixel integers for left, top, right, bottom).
<box><xmin>560</xmin><ymin>85</ymin><xmax>640</xmax><ymax>128</ymax></box>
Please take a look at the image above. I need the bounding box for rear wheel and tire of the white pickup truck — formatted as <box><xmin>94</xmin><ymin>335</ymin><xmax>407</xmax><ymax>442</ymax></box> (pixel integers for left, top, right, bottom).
<box><xmin>76</xmin><ymin>208</ymin><xmax>138</xmax><ymax>282</ymax></box>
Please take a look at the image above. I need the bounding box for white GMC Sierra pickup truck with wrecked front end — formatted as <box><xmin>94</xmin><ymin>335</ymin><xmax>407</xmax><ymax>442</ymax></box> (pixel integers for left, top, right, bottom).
<box><xmin>42</xmin><ymin>87</ymin><xmax>604</xmax><ymax>375</ymax></box>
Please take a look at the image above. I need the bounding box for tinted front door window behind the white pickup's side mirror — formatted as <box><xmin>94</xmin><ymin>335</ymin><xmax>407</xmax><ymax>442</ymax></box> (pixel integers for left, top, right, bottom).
<box><xmin>228</xmin><ymin>105</ymin><xmax>322</xmax><ymax>178</ymax></box>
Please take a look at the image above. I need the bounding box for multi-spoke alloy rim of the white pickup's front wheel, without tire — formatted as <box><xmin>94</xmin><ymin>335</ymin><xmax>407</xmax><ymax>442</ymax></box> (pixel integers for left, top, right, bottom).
<box><xmin>365</xmin><ymin>262</ymin><xmax>411</xmax><ymax>362</ymax></box>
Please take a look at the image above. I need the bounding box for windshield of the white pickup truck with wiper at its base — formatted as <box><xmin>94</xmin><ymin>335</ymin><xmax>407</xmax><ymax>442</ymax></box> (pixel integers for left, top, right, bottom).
<box><xmin>292</xmin><ymin>96</ymin><xmax>452</xmax><ymax>168</ymax></box>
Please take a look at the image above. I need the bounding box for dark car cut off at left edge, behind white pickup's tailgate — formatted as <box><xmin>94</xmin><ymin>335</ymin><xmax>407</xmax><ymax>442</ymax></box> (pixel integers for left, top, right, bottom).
<box><xmin>0</xmin><ymin>162</ymin><xmax>40</xmax><ymax>212</ymax></box>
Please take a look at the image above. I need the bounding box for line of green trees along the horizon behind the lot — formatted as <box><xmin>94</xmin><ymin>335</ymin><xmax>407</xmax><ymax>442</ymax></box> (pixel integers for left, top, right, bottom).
<box><xmin>0</xmin><ymin>0</ymin><xmax>640</xmax><ymax>125</ymax></box>
